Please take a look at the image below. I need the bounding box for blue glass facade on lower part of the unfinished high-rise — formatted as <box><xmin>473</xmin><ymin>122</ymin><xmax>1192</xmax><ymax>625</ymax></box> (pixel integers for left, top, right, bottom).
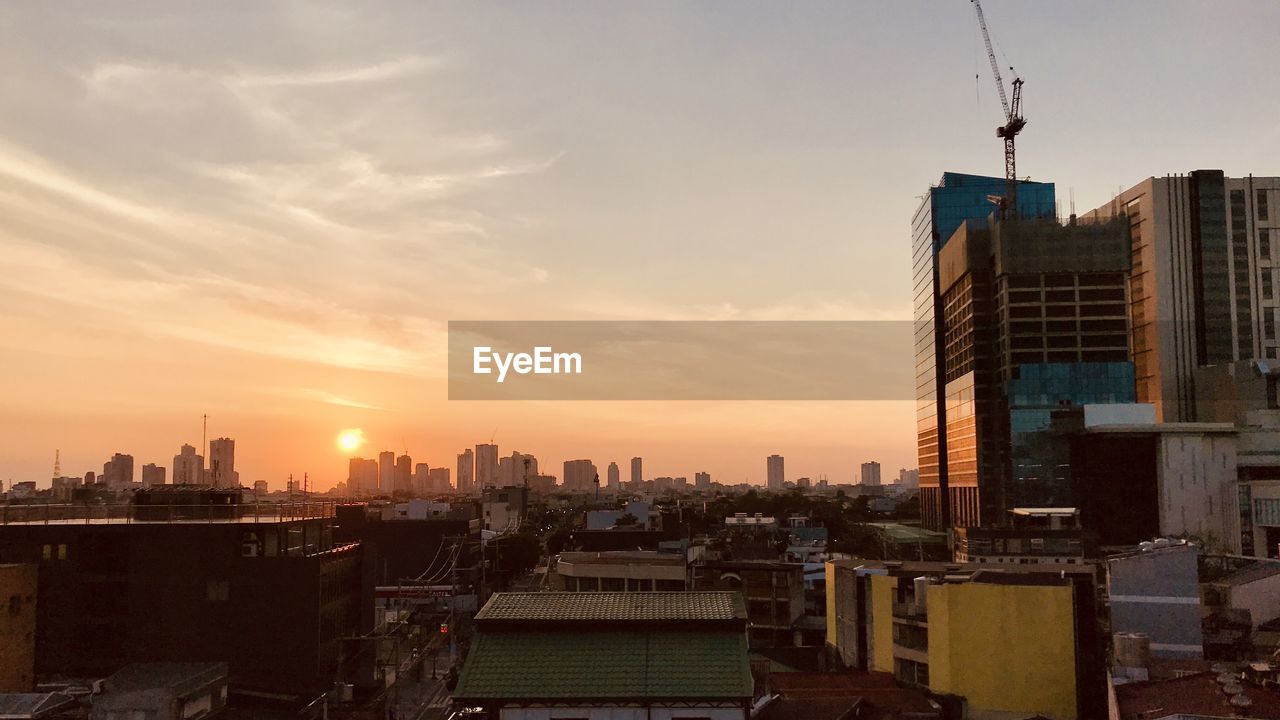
<box><xmin>1006</xmin><ymin>363</ymin><xmax>1137</xmax><ymax>507</ymax></box>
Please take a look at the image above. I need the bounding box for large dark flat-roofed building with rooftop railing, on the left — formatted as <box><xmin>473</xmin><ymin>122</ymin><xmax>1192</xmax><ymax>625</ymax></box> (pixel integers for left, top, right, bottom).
<box><xmin>0</xmin><ymin>486</ymin><xmax>372</xmax><ymax>693</ymax></box>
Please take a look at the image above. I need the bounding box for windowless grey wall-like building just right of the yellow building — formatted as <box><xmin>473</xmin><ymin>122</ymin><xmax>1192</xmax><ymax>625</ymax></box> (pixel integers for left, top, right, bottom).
<box><xmin>1106</xmin><ymin>542</ymin><xmax>1204</xmax><ymax>661</ymax></box>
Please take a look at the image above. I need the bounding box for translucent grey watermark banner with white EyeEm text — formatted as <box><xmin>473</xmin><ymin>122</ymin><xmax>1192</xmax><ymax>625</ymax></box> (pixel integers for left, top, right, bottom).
<box><xmin>449</xmin><ymin>320</ymin><xmax>915</xmax><ymax>400</ymax></box>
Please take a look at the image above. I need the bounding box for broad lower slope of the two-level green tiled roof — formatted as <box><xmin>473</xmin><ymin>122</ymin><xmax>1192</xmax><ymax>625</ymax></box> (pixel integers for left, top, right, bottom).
<box><xmin>453</xmin><ymin>630</ymin><xmax>751</xmax><ymax>701</ymax></box>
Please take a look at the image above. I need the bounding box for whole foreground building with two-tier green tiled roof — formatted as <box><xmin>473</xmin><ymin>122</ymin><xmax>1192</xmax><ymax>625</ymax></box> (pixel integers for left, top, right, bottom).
<box><xmin>453</xmin><ymin>592</ymin><xmax>753</xmax><ymax>720</ymax></box>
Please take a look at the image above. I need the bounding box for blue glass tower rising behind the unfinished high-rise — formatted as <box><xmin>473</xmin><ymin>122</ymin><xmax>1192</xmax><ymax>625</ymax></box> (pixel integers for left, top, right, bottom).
<box><xmin>911</xmin><ymin>173</ymin><xmax>1056</xmax><ymax>529</ymax></box>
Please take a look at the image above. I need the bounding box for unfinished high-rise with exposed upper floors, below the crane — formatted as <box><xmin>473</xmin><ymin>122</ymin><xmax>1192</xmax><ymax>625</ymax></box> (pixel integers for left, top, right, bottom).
<box><xmin>922</xmin><ymin>210</ymin><xmax>1134</xmax><ymax>528</ymax></box>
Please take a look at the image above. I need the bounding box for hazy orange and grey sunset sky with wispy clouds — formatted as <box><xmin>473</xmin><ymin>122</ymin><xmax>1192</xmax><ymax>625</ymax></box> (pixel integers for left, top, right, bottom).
<box><xmin>0</xmin><ymin>0</ymin><xmax>1280</xmax><ymax>489</ymax></box>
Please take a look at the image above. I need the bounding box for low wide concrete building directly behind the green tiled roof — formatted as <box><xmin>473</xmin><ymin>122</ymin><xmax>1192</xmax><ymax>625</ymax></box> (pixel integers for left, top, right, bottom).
<box><xmin>549</xmin><ymin>550</ymin><xmax>689</xmax><ymax>592</ymax></box>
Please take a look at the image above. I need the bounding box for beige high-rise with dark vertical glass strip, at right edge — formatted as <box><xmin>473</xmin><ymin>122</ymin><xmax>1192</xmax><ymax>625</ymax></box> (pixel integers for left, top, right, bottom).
<box><xmin>1082</xmin><ymin>170</ymin><xmax>1280</xmax><ymax>423</ymax></box>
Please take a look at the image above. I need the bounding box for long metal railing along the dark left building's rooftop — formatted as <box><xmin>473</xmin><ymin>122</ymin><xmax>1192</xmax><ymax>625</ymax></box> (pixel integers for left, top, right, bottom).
<box><xmin>0</xmin><ymin>501</ymin><xmax>339</xmax><ymax>525</ymax></box>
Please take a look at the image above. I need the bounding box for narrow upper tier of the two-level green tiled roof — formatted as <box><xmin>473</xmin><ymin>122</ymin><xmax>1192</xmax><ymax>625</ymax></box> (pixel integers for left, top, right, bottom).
<box><xmin>476</xmin><ymin>592</ymin><xmax>746</xmax><ymax>624</ymax></box>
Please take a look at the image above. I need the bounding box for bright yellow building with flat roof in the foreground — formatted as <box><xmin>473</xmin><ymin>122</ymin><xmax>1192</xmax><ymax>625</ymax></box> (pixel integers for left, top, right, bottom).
<box><xmin>827</xmin><ymin>560</ymin><xmax>1106</xmax><ymax>720</ymax></box>
